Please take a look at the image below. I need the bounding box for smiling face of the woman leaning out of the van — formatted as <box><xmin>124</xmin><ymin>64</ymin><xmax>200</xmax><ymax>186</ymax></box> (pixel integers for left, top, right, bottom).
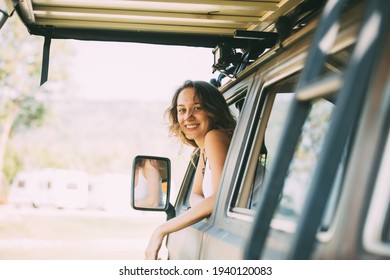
<box><xmin>177</xmin><ymin>88</ymin><xmax>211</xmax><ymax>148</ymax></box>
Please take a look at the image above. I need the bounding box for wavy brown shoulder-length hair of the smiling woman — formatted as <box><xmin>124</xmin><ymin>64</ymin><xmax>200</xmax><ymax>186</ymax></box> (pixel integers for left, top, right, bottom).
<box><xmin>166</xmin><ymin>80</ymin><xmax>236</xmax><ymax>148</ymax></box>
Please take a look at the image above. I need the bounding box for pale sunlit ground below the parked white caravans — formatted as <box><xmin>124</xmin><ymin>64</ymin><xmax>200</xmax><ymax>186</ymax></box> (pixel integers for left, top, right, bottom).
<box><xmin>0</xmin><ymin>205</ymin><xmax>165</xmax><ymax>260</ymax></box>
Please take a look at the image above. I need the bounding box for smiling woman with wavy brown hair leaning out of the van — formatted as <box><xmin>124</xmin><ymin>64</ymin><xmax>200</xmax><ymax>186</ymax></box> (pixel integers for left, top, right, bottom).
<box><xmin>145</xmin><ymin>81</ymin><xmax>236</xmax><ymax>259</ymax></box>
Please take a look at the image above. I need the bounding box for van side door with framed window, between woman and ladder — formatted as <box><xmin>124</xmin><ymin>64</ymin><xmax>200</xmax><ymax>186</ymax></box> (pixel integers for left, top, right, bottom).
<box><xmin>201</xmin><ymin>69</ymin><xmax>296</xmax><ymax>259</ymax></box>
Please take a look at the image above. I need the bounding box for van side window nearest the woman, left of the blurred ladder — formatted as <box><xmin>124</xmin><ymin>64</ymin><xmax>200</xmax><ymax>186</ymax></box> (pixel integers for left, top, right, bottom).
<box><xmin>230</xmin><ymin>83</ymin><xmax>294</xmax><ymax>219</ymax></box>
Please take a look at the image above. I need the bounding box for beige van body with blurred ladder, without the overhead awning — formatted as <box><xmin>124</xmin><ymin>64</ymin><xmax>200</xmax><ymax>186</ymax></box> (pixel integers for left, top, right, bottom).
<box><xmin>135</xmin><ymin>1</ymin><xmax>390</xmax><ymax>259</ymax></box>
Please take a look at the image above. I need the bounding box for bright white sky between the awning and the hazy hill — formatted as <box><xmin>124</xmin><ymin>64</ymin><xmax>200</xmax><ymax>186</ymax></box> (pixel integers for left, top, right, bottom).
<box><xmin>64</xmin><ymin>38</ymin><xmax>218</xmax><ymax>101</ymax></box>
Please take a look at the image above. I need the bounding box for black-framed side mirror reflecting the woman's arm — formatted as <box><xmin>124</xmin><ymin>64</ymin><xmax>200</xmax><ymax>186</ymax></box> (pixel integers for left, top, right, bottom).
<box><xmin>131</xmin><ymin>155</ymin><xmax>175</xmax><ymax>219</ymax></box>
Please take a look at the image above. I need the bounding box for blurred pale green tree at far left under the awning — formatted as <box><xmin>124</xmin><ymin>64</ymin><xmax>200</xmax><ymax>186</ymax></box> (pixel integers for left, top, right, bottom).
<box><xmin>0</xmin><ymin>15</ymin><xmax>69</xmax><ymax>202</ymax></box>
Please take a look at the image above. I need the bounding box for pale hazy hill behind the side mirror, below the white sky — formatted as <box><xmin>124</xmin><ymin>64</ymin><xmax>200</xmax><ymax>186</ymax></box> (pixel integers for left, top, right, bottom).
<box><xmin>12</xmin><ymin>100</ymin><xmax>191</xmax><ymax>185</ymax></box>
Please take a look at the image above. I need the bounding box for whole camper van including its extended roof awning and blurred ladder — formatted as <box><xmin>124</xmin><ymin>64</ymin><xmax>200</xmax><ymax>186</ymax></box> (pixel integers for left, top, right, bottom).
<box><xmin>1</xmin><ymin>0</ymin><xmax>390</xmax><ymax>259</ymax></box>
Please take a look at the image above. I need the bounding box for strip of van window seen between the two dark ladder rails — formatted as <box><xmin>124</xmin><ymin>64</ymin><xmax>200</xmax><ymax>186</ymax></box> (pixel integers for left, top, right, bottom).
<box><xmin>264</xmin><ymin>98</ymin><xmax>334</xmax><ymax>259</ymax></box>
